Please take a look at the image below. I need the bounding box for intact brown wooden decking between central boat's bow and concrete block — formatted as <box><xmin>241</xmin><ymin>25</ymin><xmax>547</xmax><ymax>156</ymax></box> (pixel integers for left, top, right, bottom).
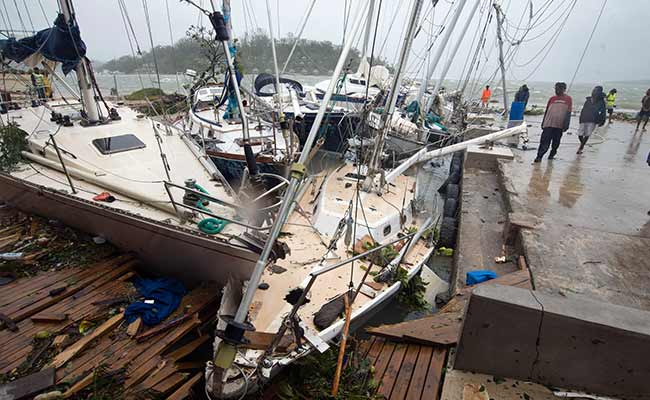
<box><xmin>361</xmin><ymin>336</ymin><xmax>447</xmax><ymax>400</ymax></box>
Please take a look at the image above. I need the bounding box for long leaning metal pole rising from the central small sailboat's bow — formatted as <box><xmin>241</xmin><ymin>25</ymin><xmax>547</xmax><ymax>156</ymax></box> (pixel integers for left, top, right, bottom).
<box><xmin>234</xmin><ymin>0</ymin><xmax>368</xmax><ymax>324</ymax></box>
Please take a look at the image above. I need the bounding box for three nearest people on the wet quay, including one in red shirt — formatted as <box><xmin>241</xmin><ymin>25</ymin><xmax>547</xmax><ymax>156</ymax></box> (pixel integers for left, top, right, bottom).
<box><xmin>532</xmin><ymin>82</ymin><xmax>650</xmax><ymax>163</ymax></box>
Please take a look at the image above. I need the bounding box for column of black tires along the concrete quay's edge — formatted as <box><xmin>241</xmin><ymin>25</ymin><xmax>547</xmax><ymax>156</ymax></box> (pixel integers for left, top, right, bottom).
<box><xmin>438</xmin><ymin>152</ymin><xmax>463</xmax><ymax>249</ymax></box>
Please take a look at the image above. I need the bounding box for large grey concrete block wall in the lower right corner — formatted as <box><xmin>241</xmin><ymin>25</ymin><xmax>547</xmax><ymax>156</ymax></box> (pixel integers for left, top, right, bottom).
<box><xmin>455</xmin><ymin>285</ymin><xmax>650</xmax><ymax>399</ymax></box>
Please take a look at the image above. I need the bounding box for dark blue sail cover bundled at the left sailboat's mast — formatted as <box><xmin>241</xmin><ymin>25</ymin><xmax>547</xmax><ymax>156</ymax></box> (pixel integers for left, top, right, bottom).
<box><xmin>0</xmin><ymin>14</ymin><xmax>86</xmax><ymax>75</ymax></box>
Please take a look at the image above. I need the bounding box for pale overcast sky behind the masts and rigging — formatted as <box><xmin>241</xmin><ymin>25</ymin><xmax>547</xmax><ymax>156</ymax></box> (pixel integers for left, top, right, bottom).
<box><xmin>5</xmin><ymin>0</ymin><xmax>650</xmax><ymax>82</ymax></box>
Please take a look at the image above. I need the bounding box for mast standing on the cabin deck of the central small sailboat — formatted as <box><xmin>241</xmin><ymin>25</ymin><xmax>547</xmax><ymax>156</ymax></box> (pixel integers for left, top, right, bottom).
<box><xmin>364</xmin><ymin>0</ymin><xmax>423</xmax><ymax>182</ymax></box>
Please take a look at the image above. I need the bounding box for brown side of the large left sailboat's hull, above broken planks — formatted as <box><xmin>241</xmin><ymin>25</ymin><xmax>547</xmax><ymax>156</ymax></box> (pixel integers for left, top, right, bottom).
<box><xmin>0</xmin><ymin>173</ymin><xmax>258</xmax><ymax>284</ymax></box>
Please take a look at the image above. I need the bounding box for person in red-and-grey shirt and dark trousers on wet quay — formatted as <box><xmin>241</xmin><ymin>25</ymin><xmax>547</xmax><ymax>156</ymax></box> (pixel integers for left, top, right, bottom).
<box><xmin>534</xmin><ymin>82</ymin><xmax>573</xmax><ymax>163</ymax></box>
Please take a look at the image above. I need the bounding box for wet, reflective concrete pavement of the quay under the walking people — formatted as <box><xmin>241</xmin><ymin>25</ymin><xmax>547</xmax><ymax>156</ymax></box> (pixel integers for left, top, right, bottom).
<box><xmin>502</xmin><ymin>119</ymin><xmax>650</xmax><ymax>310</ymax></box>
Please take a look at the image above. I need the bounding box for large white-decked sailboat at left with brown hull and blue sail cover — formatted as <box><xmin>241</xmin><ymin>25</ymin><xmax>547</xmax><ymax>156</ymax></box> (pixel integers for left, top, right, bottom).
<box><xmin>0</xmin><ymin>0</ymin><xmax>292</xmax><ymax>283</ymax></box>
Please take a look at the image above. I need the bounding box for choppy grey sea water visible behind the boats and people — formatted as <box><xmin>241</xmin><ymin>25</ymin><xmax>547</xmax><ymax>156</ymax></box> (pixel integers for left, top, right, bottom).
<box><xmin>83</xmin><ymin>74</ymin><xmax>650</xmax><ymax>112</ymax></box>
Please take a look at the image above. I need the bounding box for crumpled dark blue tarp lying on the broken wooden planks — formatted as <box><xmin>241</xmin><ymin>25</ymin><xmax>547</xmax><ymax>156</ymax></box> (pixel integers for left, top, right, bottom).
<box><xmin>124</xmin><ymin>278</ymin><xmax>186</xmax><ymax>326</ymax></box>
